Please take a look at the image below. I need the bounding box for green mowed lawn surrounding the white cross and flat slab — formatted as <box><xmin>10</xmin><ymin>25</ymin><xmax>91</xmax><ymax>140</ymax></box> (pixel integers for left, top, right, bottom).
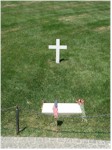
<box><xmin>1</xmin><ymin>1</ymin><xmax>110</xmax><ymax>139</ymax></box>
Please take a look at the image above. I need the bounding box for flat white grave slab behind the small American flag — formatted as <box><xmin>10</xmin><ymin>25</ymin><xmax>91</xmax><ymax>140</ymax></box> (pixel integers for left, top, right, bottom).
<box><xmin>42</xmin><ymin>103</ymin><xmax>82</xmax><ymax>114</ymax></box>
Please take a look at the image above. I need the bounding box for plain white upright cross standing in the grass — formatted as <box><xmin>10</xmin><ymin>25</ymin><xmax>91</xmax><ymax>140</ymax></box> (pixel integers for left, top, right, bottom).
<box><xmin>48</xmin><ymin>39</ymin><xmax>67</xmax><ymax>64</ymax></box>
